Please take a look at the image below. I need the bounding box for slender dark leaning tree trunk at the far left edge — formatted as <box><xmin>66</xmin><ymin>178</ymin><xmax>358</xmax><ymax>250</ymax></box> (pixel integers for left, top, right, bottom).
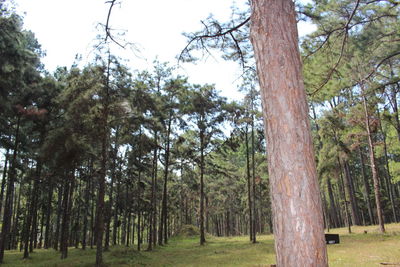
<box><xmin>0</xmin><ymin>115</ymin><xmax>21</xmax><ymax>263</ymax></box>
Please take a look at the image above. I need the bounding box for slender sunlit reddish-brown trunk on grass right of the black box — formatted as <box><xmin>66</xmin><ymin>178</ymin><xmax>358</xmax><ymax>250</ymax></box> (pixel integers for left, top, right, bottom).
<box><xmin>361</xmin><ymin>88</ymin><xmax>385</xmax><ymax>233</ymax></box>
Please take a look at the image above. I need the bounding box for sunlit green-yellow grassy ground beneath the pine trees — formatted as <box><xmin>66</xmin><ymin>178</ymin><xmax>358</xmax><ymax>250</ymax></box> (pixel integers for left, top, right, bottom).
<box><xmin>2</xmin><ymin>224</ymin><xmax>400</xmax><ymax>267</ymax></box>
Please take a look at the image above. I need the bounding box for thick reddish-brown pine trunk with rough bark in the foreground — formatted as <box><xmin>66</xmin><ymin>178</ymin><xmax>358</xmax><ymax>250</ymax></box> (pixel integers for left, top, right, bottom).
<box><xmin>251</xmin><ymin>0</ymin><xmax>328</xmax><ymax>267</ymax></box>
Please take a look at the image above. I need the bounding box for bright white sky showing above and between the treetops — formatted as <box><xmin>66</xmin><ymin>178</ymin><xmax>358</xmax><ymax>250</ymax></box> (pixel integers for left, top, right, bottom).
<box><xmin>14</xmin><ymin>0</ymin><xmax>313</xmax><ymax>99</ymax></box>
